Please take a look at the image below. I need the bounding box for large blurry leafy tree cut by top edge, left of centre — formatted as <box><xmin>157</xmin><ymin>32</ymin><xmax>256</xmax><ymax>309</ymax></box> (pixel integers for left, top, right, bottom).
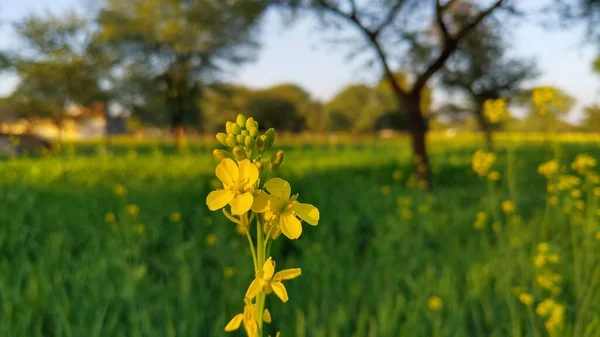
<box><xmin>98</xmin><ymin>0</ymin><xmax>266</xmax><ymax>144</ymax></box>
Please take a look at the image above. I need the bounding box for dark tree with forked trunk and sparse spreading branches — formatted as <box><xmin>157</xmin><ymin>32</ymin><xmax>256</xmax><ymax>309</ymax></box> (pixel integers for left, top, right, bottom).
<box><xmin>280</xmin><ymin>0</ymin><xmax>509</xmax><ymax>188</ymax></box>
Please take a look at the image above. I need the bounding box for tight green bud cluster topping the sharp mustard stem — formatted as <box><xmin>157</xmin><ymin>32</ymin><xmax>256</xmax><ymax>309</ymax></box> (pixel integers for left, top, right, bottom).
<box><xmin>213</xmin><ymin>115</ymin><xmax>283</xmax><ymax>171</ymax></box>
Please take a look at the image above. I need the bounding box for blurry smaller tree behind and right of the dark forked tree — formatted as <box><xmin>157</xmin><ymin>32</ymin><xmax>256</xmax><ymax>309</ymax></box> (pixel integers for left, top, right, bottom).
<box><xmin>441</xmin><ymin>3</ymin><xmax>537</xmax><ymax>150</ymax></box>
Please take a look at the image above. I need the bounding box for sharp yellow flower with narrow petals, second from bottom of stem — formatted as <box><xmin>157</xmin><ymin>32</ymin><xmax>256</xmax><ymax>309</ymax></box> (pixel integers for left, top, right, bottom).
<box><xmin>246</xmin><ymin>257</ymin><xmax>302</xmax><ymax>303</ymax></box>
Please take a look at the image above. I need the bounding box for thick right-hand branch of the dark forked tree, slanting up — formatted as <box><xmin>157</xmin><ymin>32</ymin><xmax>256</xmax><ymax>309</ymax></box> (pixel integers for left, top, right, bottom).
<box><xmin>410</xmin><ymin>0</ymin><xmax>504</xmax><ymax>94</ymax></box>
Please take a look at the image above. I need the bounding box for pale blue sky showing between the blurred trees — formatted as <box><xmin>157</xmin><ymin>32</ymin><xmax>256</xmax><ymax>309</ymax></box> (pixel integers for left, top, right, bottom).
<box><xmin>0</xmin><ymin>0</ymin><xmax>600</xmax><ymax>121</ymax></box>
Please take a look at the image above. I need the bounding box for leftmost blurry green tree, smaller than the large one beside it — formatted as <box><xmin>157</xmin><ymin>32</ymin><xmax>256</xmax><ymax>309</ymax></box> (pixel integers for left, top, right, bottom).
<box><xmin>5</xmin><ymin>12</ymin><xmax>105</xmax><ymax>140</ymax></box>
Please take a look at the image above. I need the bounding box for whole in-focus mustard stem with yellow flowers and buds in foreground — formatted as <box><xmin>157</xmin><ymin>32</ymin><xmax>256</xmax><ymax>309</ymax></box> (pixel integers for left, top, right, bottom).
<box><xmin>206</xmin><ymin>115</ymin><xmax>320</xmax><ymax>337</ymax></box>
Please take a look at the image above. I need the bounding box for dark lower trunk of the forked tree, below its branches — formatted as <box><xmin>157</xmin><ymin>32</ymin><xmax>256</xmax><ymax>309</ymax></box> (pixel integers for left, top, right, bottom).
<box><xmin>404</xmin><ymin>93</ymin><xmax>433</xmax><ymax>191</ymax></box>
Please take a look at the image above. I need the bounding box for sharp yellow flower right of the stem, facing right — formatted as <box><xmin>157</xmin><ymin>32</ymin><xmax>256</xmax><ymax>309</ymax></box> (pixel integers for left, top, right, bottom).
<box><xmin>252</xmin><ymin>178</ymin><xmax>320</xmax><ymax>240</ymax></box>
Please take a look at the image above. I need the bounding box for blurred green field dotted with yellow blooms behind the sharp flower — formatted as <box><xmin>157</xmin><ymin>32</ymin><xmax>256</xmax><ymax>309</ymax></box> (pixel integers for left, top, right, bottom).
<box><xmin>0</xmin><ymin>136</ymin><xmax>600</xmax><ymax>337</ymax></box>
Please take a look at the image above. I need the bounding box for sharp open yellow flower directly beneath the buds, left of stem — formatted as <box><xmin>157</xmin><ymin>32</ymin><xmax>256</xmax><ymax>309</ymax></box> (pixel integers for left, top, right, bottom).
<box><xmin>206</xmin><ymin>158</ymin><xmax>259</xmax><ymax>215</ymax></box>
